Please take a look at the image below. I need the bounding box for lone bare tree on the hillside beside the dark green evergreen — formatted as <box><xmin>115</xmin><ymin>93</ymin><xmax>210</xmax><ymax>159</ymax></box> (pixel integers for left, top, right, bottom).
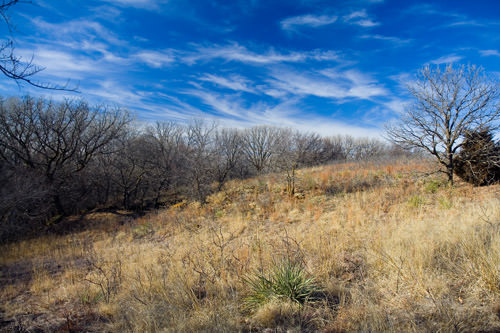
<box><xmin>387</xmin><ymin>65</ymin><xmax>500</xmax><ymax>184</ymax></box>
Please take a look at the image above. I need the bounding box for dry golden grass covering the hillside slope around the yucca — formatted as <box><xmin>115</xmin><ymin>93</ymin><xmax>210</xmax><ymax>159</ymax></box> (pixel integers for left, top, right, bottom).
<box><xmin>0</xmin><ymin>161</ymin><xmax>500</xmax><ymax>332</ymax></box>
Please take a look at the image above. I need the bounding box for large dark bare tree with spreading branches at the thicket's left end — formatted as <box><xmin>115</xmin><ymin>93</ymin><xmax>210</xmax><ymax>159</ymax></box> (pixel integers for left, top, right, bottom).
<box><xmin>0</xmin><ymin>97</ymin><xmax>130</xmax><ymax>239</ymax></box>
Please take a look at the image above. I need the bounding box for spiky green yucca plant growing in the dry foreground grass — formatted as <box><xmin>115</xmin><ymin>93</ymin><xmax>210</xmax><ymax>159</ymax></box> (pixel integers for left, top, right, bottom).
<box><xmin>245</xmin><ymin>260</ymin><xmax>320</xmax><ymax>308</ymax></box>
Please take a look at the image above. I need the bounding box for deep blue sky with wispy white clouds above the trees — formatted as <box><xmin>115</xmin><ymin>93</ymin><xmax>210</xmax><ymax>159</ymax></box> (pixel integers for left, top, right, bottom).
<box><xmin>0</xmin><ymin>0</ymin><xmax>500</xmax><ymax>137</ymax></box>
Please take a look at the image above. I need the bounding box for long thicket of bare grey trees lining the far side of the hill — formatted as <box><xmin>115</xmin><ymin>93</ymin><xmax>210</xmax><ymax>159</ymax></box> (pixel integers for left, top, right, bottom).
<box><xmin>0</xmin><ymin>97</ymin><xmax>410</xmax><ymax>238</ymax></box>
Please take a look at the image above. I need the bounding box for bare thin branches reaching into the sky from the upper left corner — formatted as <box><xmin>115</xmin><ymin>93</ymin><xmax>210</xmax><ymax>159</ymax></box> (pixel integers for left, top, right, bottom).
<box><xmin>0</xmin><ymin>0</ymin><xmax>77</xmax><ymax>91</ymax></box>
